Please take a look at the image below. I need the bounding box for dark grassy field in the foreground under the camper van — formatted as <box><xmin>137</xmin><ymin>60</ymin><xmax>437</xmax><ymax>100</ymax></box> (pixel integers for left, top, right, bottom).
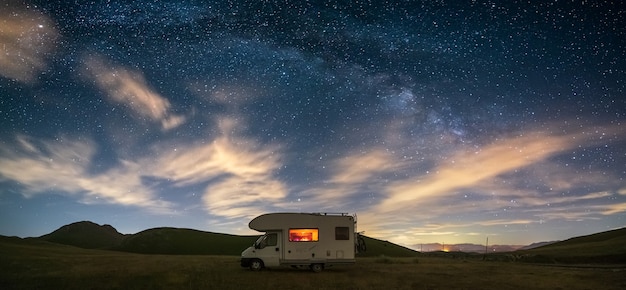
<box><xmin>0</xmin><ymin>240</ymin><xmax>626</xmax><ymax>289</ymax></box>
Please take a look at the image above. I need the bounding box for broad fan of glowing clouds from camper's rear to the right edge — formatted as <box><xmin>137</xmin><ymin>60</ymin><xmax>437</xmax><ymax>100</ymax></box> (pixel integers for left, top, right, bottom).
<box><xmin>359</xmin><ymin>126</ymin><xmax>624</xmax><ymax>241</ymax></box>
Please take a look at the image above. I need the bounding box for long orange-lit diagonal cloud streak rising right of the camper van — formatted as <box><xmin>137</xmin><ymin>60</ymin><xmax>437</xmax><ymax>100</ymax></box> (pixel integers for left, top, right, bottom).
<box><xmin>378</xmin><ymin>128</ymin><xmax>616</xmax><ymax>211</ymax></box>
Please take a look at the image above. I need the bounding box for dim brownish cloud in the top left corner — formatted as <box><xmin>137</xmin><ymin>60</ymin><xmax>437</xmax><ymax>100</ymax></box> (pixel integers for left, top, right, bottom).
<box><xmin>0</xmin><ymin>5</ymin><xmax>59</xmax><ymax>83</ymax></box>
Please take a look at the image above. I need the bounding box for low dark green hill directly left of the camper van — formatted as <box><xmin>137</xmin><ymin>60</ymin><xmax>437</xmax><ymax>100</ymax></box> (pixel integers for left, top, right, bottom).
<box><xmin>113</xmin><ymin>228</ymin><xmax>258</xmax><ymax>255</ymax></box>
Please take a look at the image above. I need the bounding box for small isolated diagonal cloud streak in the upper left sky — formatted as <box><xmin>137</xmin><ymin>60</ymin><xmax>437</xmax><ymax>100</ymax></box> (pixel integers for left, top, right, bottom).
<box><xmin>84</xmin><ymin>56</ymin><xmax>186</xmax><ymax>130</ymax></box>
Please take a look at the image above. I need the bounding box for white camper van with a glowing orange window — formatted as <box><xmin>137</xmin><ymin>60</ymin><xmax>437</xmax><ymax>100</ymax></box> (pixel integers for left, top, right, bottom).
<box><xmin>241</xmin><ymin>213</ymin><xmax>363</xmax><ymax>272</ymax></box>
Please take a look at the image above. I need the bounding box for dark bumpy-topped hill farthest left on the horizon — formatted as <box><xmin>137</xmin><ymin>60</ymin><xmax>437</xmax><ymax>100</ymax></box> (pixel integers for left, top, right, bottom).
<box><xmin>39</xmin><ymin>221</ymin><xmax>124</xmax><ymax>249</ymax></box>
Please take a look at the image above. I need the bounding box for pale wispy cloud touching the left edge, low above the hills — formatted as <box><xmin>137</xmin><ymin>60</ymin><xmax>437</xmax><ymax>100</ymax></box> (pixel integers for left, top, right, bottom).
<box><xmin>0</xmin><ymin>136</ymin><xmax>172</xmax><ymax>213</ymax></box>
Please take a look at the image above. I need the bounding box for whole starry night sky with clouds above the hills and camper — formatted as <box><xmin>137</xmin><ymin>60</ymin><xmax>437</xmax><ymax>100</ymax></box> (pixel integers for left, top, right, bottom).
<box><xmin>0</xmin><ymin>0</ymin><xmax>626</xmax><ymax>246</ymax></box>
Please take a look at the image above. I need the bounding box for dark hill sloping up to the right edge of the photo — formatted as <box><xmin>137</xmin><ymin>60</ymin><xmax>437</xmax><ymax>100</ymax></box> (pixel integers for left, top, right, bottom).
<box><xmin>515</xmin><ymin>228</ymin><xmax>626</xmax><ymax>264</ymax></box>
